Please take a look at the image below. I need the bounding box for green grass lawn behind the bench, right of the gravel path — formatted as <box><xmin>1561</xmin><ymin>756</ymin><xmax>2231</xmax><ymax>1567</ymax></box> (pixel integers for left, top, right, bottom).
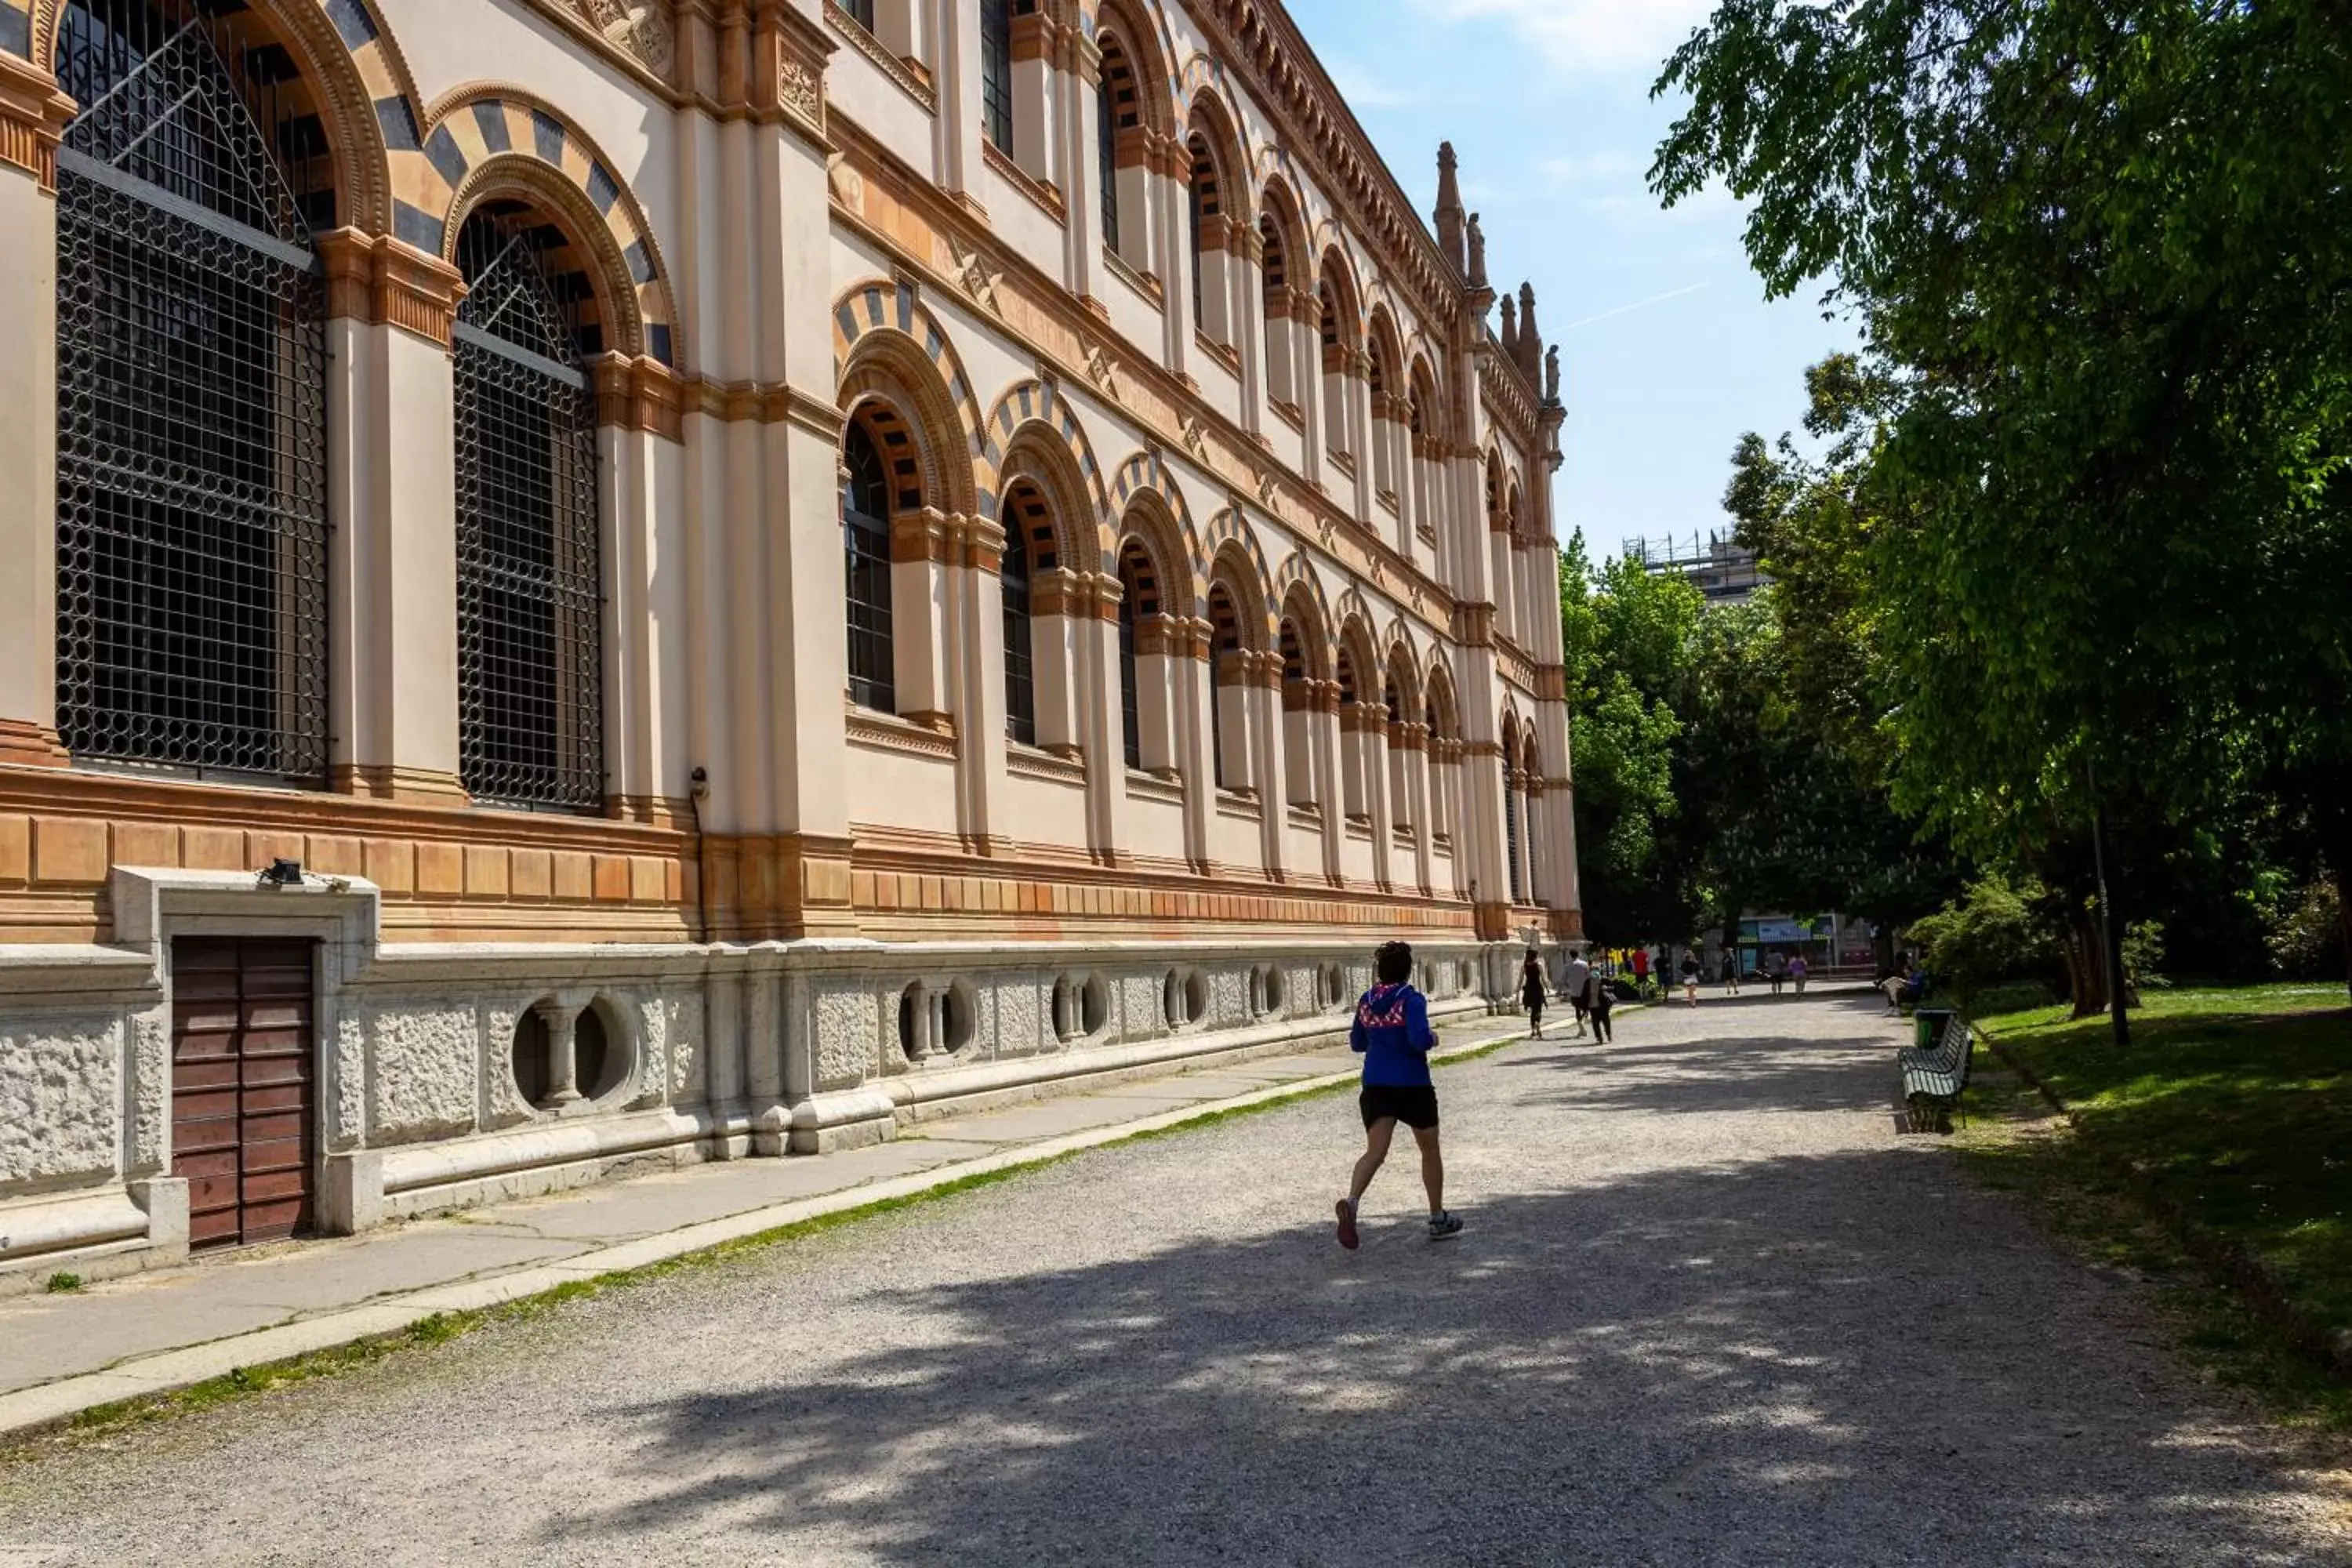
<box><xmin>1971</xmin><ymin>985</ymin><xmax>2352</xmax><ymax>1427</ymax></box>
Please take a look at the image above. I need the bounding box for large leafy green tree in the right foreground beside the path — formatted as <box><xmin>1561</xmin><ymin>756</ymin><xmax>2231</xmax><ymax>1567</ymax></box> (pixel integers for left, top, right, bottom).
<box><xmin>1651</xmin><ymin>0</ymin><xmax>2352</xmax><ymax>1006</ymax></box>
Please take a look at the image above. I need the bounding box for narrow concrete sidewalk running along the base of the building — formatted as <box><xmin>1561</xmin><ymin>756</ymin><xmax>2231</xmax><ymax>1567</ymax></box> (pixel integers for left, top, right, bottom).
<box><xmin>0</xmin><ymin>1015</ymin><xmax>1526</xmax><ymax>1434</ymax></box>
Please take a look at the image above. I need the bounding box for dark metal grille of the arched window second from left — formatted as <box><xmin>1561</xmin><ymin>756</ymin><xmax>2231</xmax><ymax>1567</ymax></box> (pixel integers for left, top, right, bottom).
<box><xmin>454</xmin><ymin>212</ymin><xmax>604</xmax><ymax>811</ymax></box>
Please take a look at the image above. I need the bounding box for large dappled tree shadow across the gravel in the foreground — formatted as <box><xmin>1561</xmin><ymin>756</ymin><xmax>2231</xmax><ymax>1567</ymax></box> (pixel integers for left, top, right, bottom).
<box><xmin>550</xmin><ymin>1149</ymin><xmax>2343</xmax><ymax>1566</ymax></box>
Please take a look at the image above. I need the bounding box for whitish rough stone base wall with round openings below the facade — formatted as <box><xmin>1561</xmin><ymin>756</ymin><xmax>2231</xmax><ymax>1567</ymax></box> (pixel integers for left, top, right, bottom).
<box><xmin>0</xmin><ymin>872</ymin><xmax>1519</xmax><ymax>1290</ymax></box>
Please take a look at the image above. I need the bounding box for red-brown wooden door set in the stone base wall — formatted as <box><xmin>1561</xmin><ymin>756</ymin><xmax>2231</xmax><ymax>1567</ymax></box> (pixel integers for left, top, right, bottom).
<box><xmin>172</xmin><ymin>935</ymin><xmax>318</xmax><ymax>1246</ymax></box>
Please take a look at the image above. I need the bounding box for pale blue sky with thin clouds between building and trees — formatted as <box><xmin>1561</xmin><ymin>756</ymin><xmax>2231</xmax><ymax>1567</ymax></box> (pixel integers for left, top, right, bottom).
<box><xmin>1287</xmin><ymin>0</ymin><xmax>1851</xmax><ymax>555</ymax></box>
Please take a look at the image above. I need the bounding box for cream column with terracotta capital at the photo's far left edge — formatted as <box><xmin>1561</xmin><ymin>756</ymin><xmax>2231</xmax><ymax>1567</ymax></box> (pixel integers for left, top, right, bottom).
<box><xmin>0</xmin><ymin>49</ymin><xmax>73</xmax><ymax>767</ymax></box>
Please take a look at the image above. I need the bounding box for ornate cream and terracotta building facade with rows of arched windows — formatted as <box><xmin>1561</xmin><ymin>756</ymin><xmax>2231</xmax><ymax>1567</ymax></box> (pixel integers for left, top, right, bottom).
<box><xmin>0</xmin><ymin>0</ymin><xmax>1578</xmax><ymax>1279</ymax></box>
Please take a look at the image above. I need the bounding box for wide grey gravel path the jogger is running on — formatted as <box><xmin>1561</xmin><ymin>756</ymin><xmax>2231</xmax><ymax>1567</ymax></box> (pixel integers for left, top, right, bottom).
<box><xmin>0</xmin><ymin>999</ymin><xmax>2352</xmax><ymax>1568</ymax></box>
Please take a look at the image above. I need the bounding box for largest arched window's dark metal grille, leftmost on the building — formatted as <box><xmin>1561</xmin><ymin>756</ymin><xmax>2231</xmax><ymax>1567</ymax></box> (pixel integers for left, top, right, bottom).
<box><xmin>56</xmin><ymin>0</ymin><xmax>334</xmax><ymax>783</ymax></box>
